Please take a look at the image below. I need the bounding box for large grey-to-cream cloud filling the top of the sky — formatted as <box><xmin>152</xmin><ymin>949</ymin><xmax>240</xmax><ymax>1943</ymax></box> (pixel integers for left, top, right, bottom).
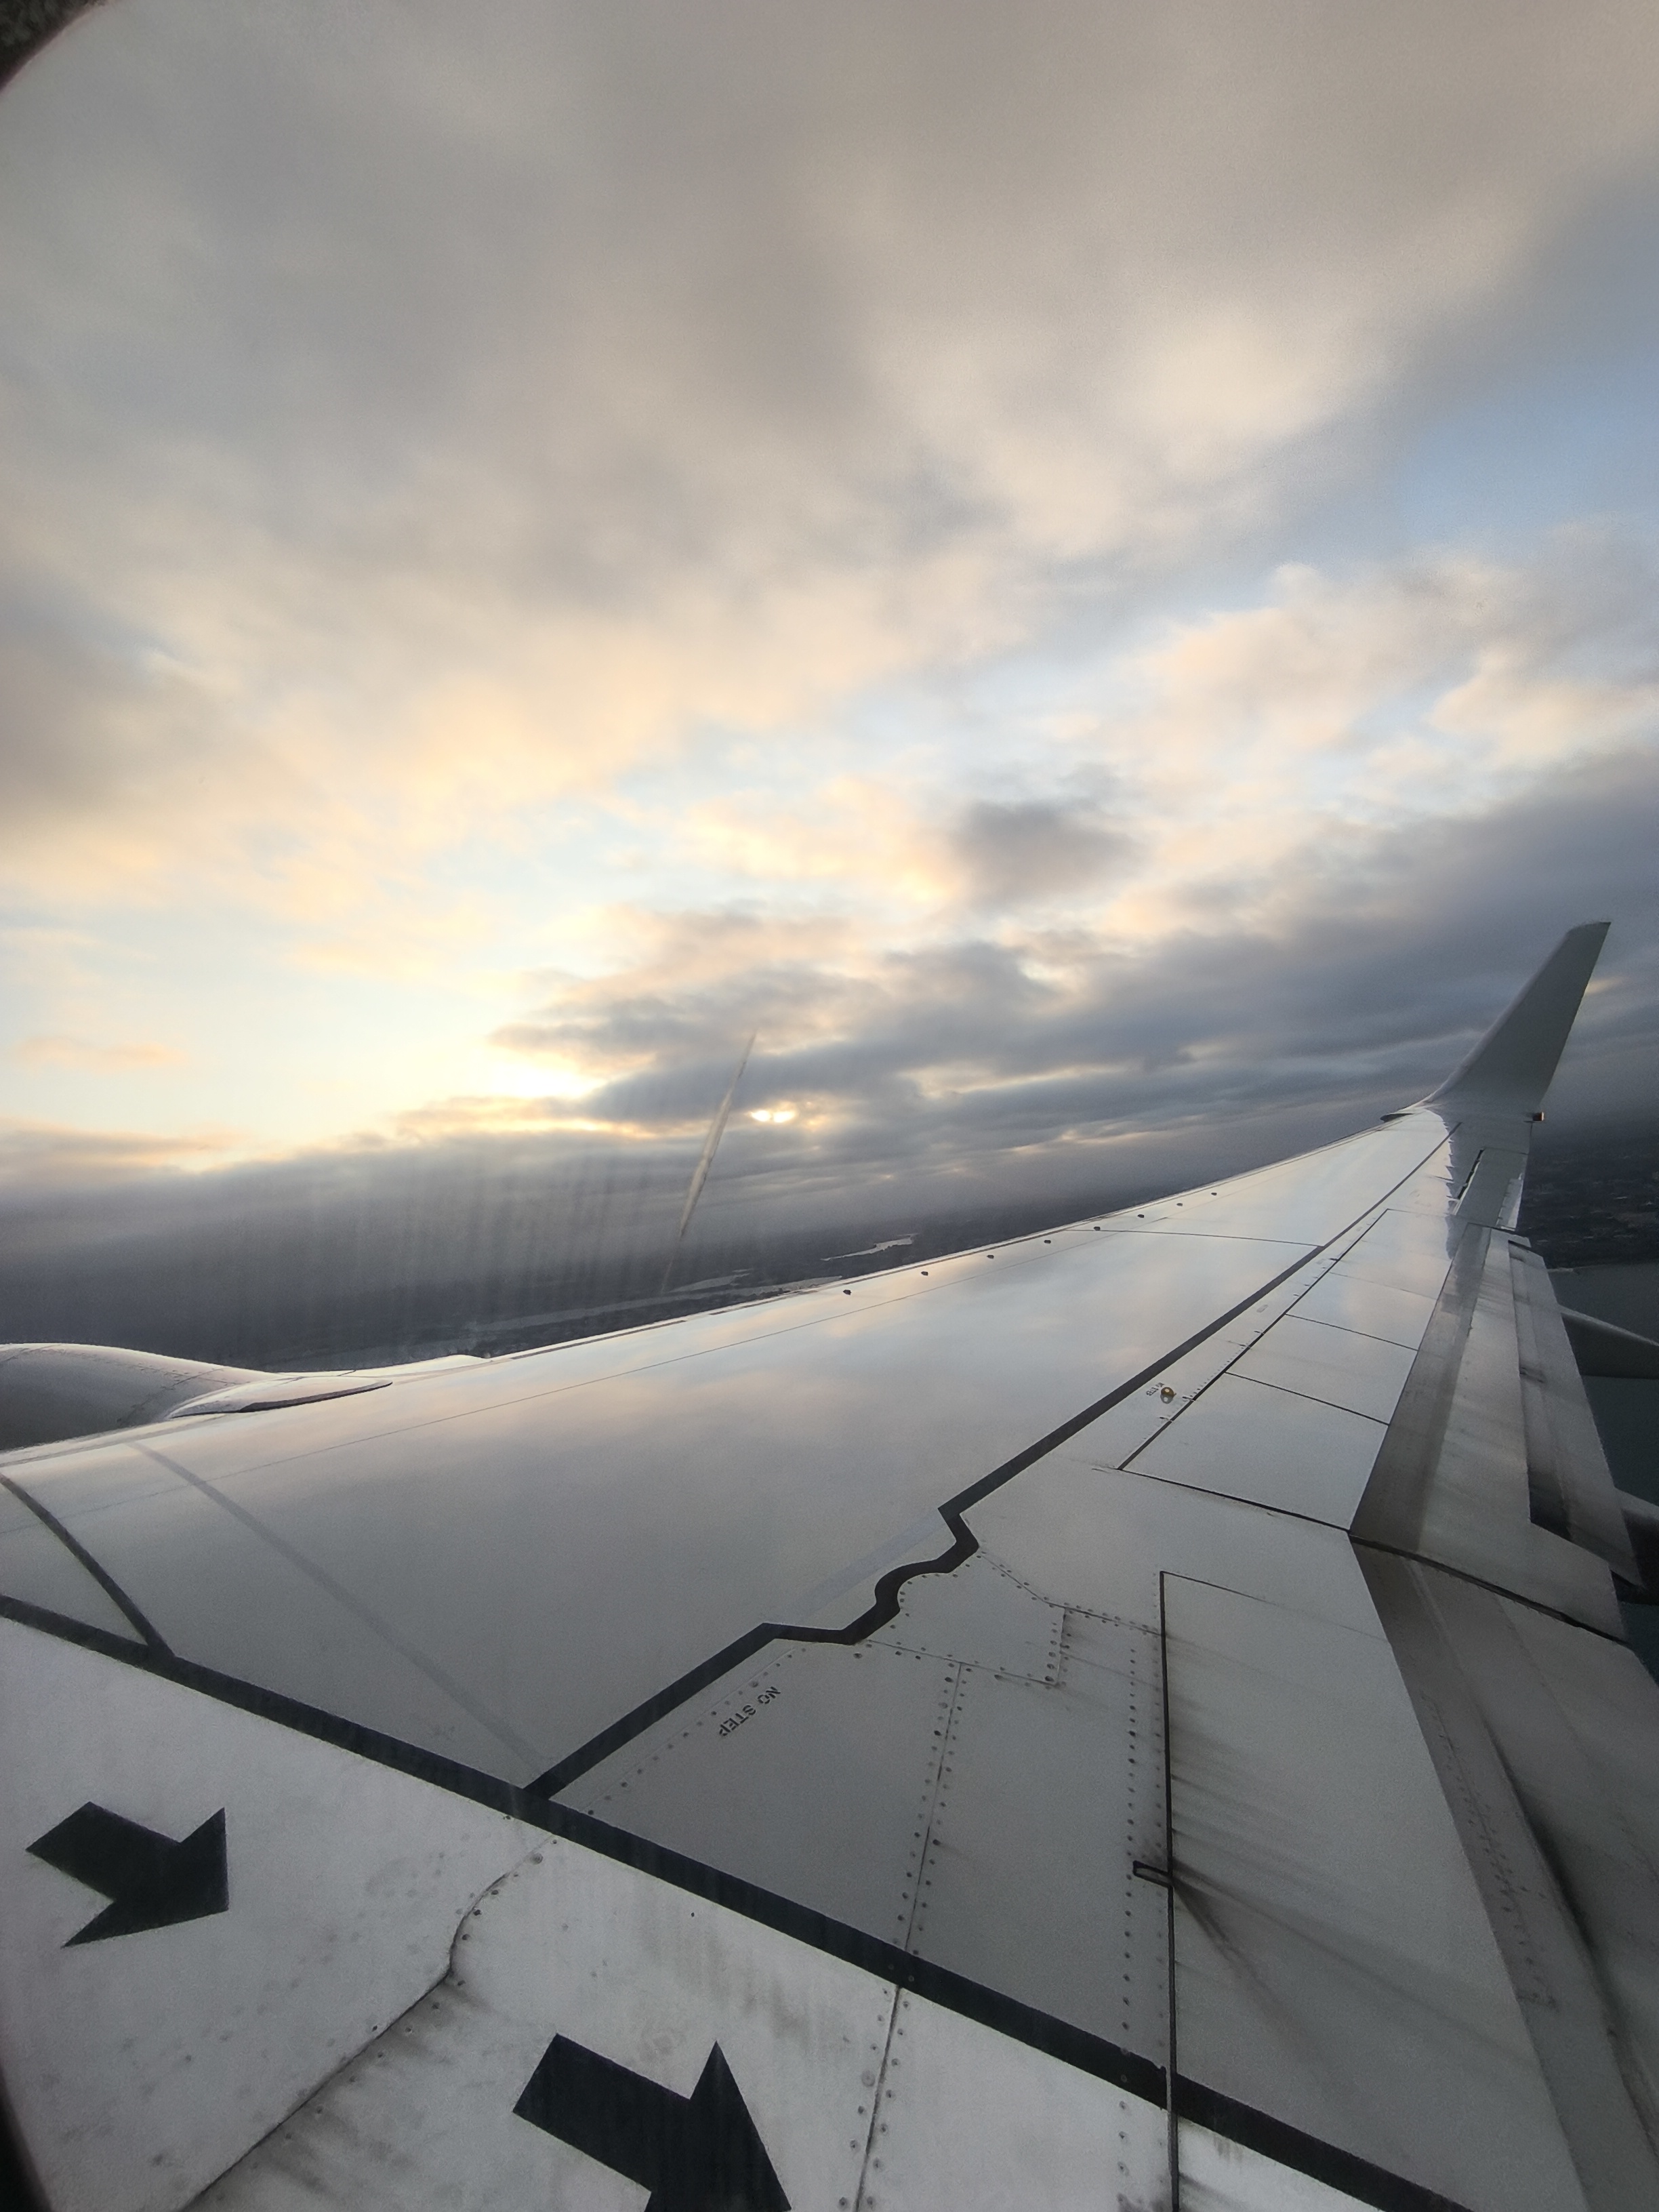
<box><xmin>5</xmin><ymin>0</ymin><xmax>1659</xmax><ymax>900</ymax></box>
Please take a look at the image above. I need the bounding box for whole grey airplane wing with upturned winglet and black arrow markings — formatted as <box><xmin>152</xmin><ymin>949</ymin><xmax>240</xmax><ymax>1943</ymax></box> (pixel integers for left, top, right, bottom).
<box><xmin>0</xmin><ymin>924</ymin><xmax>1659</xmax><ymax>2212</ymax></box>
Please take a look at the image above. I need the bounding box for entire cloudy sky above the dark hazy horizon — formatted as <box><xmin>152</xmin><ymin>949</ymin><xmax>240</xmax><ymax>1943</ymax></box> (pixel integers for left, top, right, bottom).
<box><xmin>0</xmin><ymin>0</ymin><xmax>1659</xmax><ymax>1274</ymax></box>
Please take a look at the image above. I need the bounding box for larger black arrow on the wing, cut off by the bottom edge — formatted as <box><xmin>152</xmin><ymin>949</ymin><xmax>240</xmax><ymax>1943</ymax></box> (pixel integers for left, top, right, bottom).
<box><xmin>513</xmin><ymin>2035</ymin><xmax>790</xmax><ymax>2212</ymax></box>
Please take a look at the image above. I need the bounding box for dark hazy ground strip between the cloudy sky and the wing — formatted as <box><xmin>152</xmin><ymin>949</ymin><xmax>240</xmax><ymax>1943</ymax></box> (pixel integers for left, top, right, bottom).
<box><xmin>0</xmin><ymin>1079</ymin><xmax>1659</xmax><ymax>1367</ymax></box>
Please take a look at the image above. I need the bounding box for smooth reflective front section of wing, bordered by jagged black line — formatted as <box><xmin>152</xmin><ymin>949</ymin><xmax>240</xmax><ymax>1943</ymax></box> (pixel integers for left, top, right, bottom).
<box><xmin>0</xmin><ymin>1117</ymin><xmax>1444</xmax><ymax>1781</ymax></box>
